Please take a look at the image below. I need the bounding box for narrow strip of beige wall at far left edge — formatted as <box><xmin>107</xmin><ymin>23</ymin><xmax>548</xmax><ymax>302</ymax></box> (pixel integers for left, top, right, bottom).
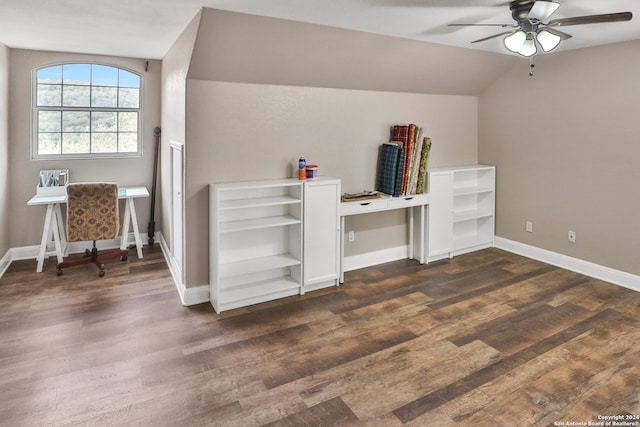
<box><xmin>0</xmin><ymin>43</ymin><xmax>11</xmax><ymax>258</ymax></box>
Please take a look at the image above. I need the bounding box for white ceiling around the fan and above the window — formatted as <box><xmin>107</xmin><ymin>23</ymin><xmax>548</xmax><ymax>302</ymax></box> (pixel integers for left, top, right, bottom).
<box><xmin>0</xmin><ymin>0</ymin><xmax>640</xmax><ymax>59</ymax></box>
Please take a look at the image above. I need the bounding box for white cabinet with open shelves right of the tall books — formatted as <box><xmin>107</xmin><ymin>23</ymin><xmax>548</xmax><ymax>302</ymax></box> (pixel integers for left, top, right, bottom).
<box><xmin>427</xmin><ymin>165</ymin><xmax>495</xmax><ymax>261</ymax></box>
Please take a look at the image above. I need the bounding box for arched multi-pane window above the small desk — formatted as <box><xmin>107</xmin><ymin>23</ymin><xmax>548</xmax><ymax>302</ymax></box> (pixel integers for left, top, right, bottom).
<box><xmin>32</xmin><ymin>64</ymin><xmax>142</xmax><ymax>159</ymax></box>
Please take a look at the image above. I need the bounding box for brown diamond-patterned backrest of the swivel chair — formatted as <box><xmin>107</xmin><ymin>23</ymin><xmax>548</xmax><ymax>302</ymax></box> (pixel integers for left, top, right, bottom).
<box><xmin>66</xmin><ymin>182</ymin><xmax>120</xmax><ymax>242</ymax></box>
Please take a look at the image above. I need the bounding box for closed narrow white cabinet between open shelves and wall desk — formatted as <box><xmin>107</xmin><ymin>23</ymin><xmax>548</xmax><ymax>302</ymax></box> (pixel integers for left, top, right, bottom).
<box><xmin>302</xmin><ymin>177</ymin><xmax>340</xmax><ymax>293</ymax></box>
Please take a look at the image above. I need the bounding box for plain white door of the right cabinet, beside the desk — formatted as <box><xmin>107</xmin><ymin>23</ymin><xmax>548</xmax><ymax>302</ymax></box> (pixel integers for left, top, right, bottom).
<box><xmin>426</xmin><ymin>173</ymin><xmax>453</xmax><ymax>261</ymax></box>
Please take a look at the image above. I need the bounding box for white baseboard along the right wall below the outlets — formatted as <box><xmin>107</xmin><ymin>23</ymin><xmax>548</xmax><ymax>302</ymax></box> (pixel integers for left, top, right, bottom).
<box><xmin>495</xmin><ymin>236</ymin><xmax>640</xmax><ymax>292</ymax></box>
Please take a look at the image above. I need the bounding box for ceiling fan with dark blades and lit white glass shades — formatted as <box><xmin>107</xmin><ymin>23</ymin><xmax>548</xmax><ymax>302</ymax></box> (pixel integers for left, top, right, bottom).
<box><xmin>449</xmin><ymin>0</ymin><xmax>633</xmax><ymax>57</ymax></box>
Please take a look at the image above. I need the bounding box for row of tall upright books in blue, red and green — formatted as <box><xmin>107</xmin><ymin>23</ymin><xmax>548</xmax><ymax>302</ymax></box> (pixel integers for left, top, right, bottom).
<box><xmin>376</xmin><ymin>124</ymin><xmax>431</xmax><ymax>197</ymax></box>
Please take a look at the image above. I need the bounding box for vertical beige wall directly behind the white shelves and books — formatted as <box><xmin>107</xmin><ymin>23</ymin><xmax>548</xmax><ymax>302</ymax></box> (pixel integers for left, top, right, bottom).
<box><xmin>186</xmin><ymin>80</ymin><xmax>477</xmax><ymax>284</ymax></box>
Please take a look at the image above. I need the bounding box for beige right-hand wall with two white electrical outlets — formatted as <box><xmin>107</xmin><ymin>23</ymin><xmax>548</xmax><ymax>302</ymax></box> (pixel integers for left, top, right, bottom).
<box><xmin>479</xmin><ymin>40</ymin><xmax>640</xmax><ymax>274</ymax></box>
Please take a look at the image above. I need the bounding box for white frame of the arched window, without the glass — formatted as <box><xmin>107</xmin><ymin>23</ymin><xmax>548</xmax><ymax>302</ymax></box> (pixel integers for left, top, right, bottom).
<box><xmin>30</xmin><ymin>61</ymin><xmax>145</xmax><ymax>160</ymax></box>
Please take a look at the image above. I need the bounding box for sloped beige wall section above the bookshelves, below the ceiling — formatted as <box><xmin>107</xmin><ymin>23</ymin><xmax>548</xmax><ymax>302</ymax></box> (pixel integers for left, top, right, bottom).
<box><xmin>189</xmin><ymin>9</ymin><xmax>517</xmax><ymax>95</ymax></box>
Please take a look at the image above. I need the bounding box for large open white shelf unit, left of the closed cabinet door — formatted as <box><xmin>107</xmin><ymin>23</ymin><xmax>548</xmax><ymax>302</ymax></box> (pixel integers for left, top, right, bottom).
<box><xmin>209</xmin><ymin>179</ymin><xmax>303</xmax><ymax>313</ymax></box>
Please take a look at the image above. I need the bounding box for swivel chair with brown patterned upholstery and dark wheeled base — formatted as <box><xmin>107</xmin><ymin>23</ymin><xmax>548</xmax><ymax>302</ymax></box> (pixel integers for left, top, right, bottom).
<box><xmin>57</xmin><ymin>182</ymin><xmax>129</xmax><ymax>277</ymax></box>
